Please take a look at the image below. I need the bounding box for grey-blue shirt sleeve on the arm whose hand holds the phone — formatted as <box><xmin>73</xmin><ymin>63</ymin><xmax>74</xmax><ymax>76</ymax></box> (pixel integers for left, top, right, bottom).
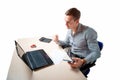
<box><xmin>85</xmin><ymin>28</ymin><xmax>101</xmax><ymax>63</ymax></box>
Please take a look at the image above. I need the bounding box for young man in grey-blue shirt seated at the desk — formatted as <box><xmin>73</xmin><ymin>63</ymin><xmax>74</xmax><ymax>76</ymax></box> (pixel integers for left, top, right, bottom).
<box><xmin>54</xmin><ymin>8</ymin><xmax>100</xmax><ymax>77</ymax></box>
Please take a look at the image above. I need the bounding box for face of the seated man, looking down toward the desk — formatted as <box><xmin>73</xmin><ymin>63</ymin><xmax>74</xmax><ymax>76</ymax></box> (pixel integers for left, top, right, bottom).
<box><xmin>65</xmin><ymin>15</ymin><xmax>78</xmax><ymax>29</ymax></box>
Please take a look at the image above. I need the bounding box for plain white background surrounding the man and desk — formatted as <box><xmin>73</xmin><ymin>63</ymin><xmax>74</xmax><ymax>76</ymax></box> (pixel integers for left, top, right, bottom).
<box><xmin>0</xmin><ymin>0</ymin><xmax>120</xmax><ymax>80</ymax></box>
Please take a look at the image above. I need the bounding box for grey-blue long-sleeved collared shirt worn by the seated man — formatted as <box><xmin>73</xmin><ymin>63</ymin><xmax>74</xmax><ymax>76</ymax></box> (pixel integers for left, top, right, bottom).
<box><xmin>58</xmin><ymin>24</ymin><xmax>101</xmax><ymax>63</ymax></box>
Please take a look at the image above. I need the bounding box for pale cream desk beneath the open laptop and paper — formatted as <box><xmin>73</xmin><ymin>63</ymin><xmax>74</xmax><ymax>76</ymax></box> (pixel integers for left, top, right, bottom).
<box><xmin>7</xmin><ymin>38</ymin><xmax>87</xmax><ymax>80</ymax></box>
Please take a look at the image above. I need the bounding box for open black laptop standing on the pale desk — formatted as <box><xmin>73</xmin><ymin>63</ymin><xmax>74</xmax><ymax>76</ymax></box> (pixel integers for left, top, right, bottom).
<box><xmin>15</xmin><ymin>41</ymin><xmax>53</xmax><ymax>70</ymax></box>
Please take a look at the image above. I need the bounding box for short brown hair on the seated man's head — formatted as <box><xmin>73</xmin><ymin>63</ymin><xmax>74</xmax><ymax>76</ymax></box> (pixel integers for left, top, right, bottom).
<box><xmin>65</xmin><ymin>8</ymin><xmax>81</xmax><ymax>20</ymax></box>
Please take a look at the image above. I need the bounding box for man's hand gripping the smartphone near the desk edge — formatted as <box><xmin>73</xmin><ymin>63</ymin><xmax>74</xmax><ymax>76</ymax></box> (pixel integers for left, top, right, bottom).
<box><xmin>69</xmin><ymin>58</ymin><xmax>86</xmax><ymax>68</ymax></box>
